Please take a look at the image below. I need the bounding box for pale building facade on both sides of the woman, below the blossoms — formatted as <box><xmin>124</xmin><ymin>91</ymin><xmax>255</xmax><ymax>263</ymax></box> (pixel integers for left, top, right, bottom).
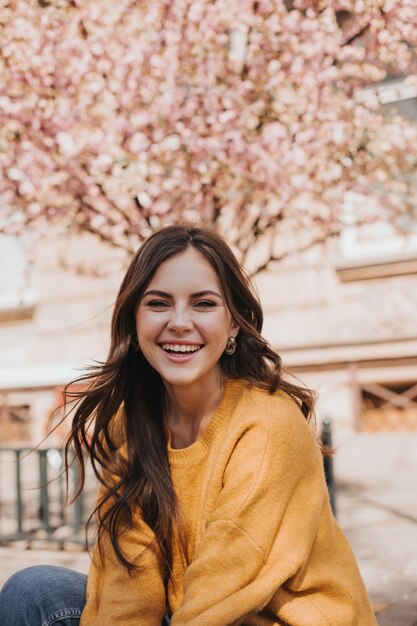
<box><xmin>0</xmin><ymin>216</ymin><xmax>417</xmax><ymax>445</ymax></box>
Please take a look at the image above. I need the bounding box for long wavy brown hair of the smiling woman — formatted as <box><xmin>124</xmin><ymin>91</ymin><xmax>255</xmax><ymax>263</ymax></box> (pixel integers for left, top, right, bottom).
<box><xmin>66</xmin><ymin>225</ymin><xmax>313</xmax><ymax>575</ymax></box>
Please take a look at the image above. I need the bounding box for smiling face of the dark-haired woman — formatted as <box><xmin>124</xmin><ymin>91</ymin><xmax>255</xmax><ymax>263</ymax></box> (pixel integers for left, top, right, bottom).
<box><xmin>136</xmin><ymin>247</ymin><xmax>239</xmax><ymax>387</ymax></box>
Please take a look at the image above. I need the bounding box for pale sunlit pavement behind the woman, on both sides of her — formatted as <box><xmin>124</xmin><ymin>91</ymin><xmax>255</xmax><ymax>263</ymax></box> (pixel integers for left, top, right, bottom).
<box><xmin>0</xmin><ymin>433</ymin><xmax>417</xmax><ymax>626</ymax></box>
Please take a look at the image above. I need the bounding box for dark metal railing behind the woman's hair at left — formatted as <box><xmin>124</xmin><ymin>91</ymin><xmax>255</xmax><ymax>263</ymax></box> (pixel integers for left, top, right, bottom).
<box><xmin>0</xmin><ymin>447</ymin><xmax>97</xmax><ymax>545</ymax></box>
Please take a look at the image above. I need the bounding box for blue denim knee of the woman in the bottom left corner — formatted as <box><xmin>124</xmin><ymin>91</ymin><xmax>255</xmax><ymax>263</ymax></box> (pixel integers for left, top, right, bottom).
<box><xmin>0</xmin><ymin>565</ymin><xmax>87</xmax><ymax>626</ymax></box>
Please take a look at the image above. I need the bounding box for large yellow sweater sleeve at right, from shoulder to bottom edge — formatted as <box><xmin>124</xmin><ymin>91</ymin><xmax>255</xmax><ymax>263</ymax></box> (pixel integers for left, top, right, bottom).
<box><xmin>168</xmin><ymin>398</ymin><xmax>376</xmax><ymax>626</ymax></box>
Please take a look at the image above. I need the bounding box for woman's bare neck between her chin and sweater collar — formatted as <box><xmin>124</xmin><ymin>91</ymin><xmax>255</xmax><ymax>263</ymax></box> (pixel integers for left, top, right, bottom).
<box><xmin>165</xmin><ymin>372</ymin><xmax>224</xmax><ymax>448</ymax></box>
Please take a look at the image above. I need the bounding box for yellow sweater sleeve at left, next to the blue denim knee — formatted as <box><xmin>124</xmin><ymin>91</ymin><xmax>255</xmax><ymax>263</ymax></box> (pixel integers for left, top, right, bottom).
<box><xmin>80</xmin><ymin>488</ymin><xmax>166</xmax><ymax>626</ymax></box>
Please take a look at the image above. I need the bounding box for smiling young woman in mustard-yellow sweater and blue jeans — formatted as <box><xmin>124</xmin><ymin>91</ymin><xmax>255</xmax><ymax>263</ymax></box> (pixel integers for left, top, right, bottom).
<box><xmin>0</xmin><ymin>226</ymin><xmax>376</xmax><ymax>626</ymax></box>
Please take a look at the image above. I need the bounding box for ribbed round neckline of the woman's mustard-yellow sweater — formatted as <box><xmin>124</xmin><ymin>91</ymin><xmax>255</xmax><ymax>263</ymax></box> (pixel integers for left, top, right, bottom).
<box><xmin>166</xmin><ymin>379</ymin><xmax>246</xmax><ymax>465</ymax></box>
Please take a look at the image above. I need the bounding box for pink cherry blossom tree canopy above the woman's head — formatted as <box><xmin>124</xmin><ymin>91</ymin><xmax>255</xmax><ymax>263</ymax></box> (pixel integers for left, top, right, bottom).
<box><xmin>0</xmin><ymin>0</ymin><xmax>417</xmax><ymax>270</ymax></box>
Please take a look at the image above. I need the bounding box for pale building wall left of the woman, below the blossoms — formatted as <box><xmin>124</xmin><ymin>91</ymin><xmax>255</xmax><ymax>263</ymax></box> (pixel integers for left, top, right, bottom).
<box><xmin>0</xmin><ymin>233</ymin><xmax>125</xmax><ymax>445</ymax></box>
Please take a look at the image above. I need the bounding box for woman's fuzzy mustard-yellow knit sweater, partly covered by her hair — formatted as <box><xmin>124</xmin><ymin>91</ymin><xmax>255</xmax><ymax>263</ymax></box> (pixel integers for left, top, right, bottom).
<box><xmin>81</xmin><ymin>380</ymin><xmax>376</xmax><ymax>626</ymax></box>
